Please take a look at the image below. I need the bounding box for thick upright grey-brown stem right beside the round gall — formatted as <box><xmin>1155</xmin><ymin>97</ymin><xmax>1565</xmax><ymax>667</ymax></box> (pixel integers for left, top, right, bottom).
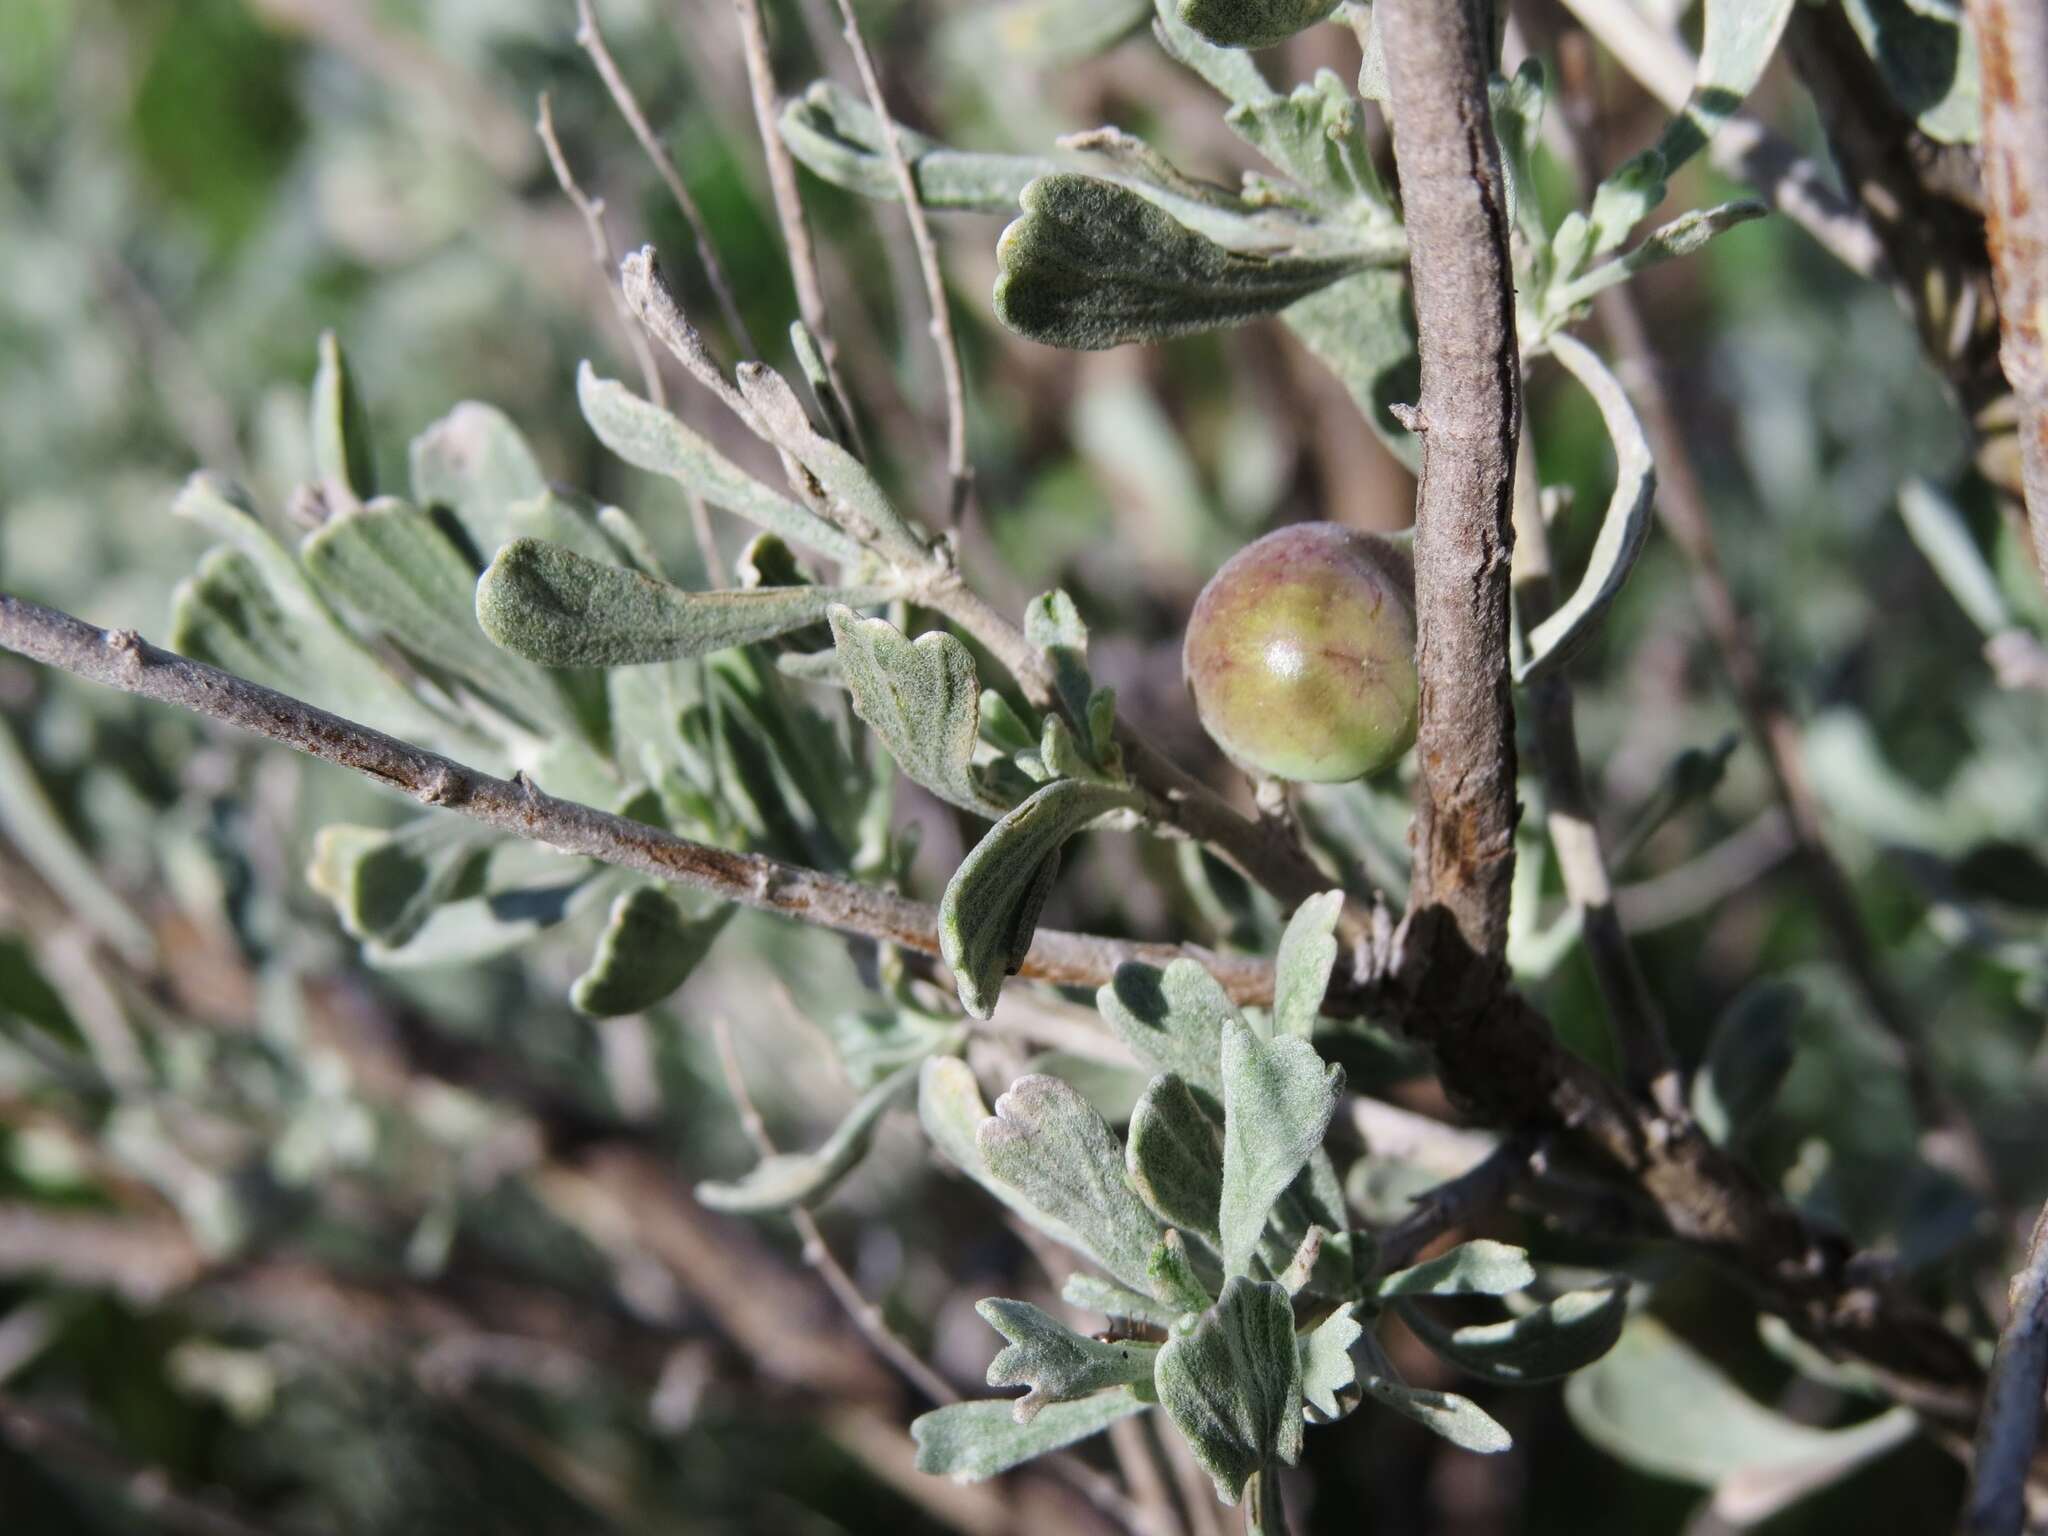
<box><xmin>1376</xmin><ymin>0</ymin><xmax>1522</xmax><ymax>962</ymax></box>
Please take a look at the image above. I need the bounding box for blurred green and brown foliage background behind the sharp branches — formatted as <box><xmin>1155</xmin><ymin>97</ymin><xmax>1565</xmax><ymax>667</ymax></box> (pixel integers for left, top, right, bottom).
<box><xmin>0</xmin><ymin>0</ymin><xmax>2048</xmax><ymax>1536</ymax></box>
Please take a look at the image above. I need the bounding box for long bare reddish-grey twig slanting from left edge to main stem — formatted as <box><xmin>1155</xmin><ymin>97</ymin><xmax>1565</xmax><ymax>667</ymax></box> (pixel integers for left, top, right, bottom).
<box><xmin>0</xmin><ymin>594</ymin><xmax>1272</xmax><ymax>1001</ymax></box>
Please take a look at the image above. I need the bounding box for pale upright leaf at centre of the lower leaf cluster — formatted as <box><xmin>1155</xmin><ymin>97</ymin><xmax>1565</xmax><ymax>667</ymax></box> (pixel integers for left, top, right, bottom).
<box><xmin>1217</xmin><ymin>1022</ymin><xmax>1343</xmax><ymax>1276</ymax></box>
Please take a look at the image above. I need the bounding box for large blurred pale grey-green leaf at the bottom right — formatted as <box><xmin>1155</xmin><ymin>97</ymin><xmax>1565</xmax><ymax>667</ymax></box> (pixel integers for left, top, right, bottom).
<box><xmin>1565</xmin><ymin>1315</ymin><xmax>1919</xmax><ymax>1524</ymax></box>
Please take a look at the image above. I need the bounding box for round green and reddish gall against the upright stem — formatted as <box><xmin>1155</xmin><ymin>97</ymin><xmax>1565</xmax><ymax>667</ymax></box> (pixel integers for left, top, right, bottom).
<box><xmin>1182</xmin><ymin>522</ymin><xmax>1419</xmax><ymax>784</ymax></box>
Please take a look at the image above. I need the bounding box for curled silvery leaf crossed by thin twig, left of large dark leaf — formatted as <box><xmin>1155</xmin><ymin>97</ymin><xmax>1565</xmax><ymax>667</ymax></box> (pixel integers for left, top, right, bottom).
<box><xmin>780</xmin><ymin>80</ymin><xmax>1055</xmax><ymax>213</ymax></box>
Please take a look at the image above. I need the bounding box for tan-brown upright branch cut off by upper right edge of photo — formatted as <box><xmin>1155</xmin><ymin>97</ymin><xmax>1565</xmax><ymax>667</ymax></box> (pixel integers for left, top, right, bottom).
<box><xmin>1970</xmin><ymin>0</ymin><xmax>2048</xmax><ymax>582</ymax></box>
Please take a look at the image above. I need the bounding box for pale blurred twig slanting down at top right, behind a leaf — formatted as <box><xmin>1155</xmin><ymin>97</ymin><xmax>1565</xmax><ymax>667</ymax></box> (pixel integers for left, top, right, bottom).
<box><xmin>1565</xmin><ymin>0</ymin><xmax>1886</xmax><ymax>279</ymax></box>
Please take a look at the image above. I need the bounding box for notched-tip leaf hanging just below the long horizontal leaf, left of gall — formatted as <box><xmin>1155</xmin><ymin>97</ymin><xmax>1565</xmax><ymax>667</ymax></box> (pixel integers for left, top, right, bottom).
<box><xmin>827</xmin><ymin>608</ymin><xmax>1008</xmax><ymax>819</ymax></box>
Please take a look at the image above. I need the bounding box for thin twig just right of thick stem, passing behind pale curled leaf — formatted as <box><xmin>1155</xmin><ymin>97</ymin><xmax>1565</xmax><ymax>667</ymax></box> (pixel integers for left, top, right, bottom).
<box><xmin>1513</xmin><ymin>421</ymin><xmax>1688</xmax><ymax>1118</ymax></box>
